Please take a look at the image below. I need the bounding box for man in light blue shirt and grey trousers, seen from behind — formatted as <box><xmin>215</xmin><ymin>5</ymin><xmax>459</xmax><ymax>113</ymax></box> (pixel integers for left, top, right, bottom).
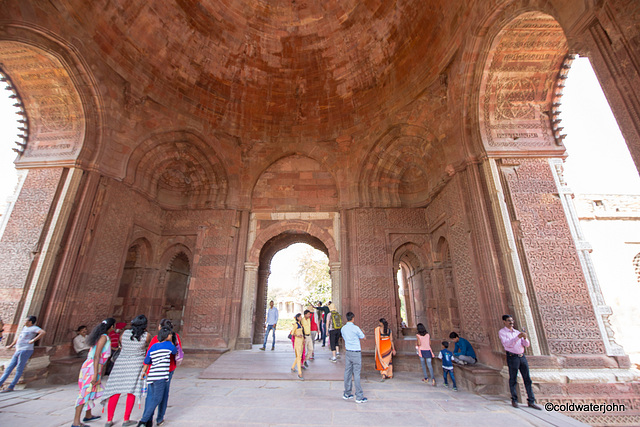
<box><xmin>340</xmin><ymin>312</ymin><xmax>367</xmax><ymax>403</ymax></box>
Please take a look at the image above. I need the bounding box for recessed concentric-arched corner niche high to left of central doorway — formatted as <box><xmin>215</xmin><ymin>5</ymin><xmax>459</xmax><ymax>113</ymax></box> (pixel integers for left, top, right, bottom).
<box><xmin>125</xmin><ymin>131</ymin><xmax>228</xmax><ymax>209</ymax></box>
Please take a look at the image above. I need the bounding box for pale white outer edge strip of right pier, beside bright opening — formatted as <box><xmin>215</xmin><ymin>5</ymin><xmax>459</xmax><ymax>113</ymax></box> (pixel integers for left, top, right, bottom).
<box><xmin>549</xmin><ymin>159</ymin><xmax>624</xmax><ymax>356</ymax></box>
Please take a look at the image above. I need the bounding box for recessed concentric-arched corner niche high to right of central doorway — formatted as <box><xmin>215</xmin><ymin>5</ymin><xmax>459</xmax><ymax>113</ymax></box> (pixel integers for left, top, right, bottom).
<box><xmin>358</xmin><ymin>124</ymin><xmax>436</xmax><ymax>207</ymax></box>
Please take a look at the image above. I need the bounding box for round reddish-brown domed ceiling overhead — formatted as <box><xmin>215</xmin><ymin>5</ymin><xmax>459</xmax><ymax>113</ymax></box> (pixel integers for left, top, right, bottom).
<box><xmin>60</xmin><ymin>0</ymin><xmax>470</xmax><ymax>139</ymax></box>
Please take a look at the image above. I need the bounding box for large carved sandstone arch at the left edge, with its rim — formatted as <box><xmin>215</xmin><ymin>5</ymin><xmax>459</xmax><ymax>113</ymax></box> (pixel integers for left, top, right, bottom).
<box><xmin>0</xmin><ymin>22</ymin><xmax>103</xmax><ymax>168</ymax></box>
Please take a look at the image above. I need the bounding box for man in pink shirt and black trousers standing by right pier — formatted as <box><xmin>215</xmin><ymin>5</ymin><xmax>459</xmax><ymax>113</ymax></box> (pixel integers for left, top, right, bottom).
<box><xmin>498</xmin><ymin>314</ymin><xmax>542</xmax><ymax>410</ymax></box>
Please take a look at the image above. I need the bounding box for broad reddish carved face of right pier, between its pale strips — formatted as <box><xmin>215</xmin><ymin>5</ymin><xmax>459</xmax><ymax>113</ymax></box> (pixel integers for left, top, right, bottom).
<box><xmin>501</xmin><ymin>158</ymin><xmax>605</xmax><ymax>356</ymax></box>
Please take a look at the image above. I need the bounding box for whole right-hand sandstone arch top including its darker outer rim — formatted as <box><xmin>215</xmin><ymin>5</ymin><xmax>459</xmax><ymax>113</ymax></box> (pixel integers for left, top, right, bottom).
<box><xmin>467</xmin><ymin>5</ymin><xmax>568</xmax><ymax>156</ymax></box>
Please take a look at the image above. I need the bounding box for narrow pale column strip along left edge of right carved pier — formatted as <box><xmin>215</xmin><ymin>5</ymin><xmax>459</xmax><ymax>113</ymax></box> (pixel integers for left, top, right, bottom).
<box><xmin>482</xmin><ymin>159</ymin><xmax>541</xmax><ymax>355</ymax></box>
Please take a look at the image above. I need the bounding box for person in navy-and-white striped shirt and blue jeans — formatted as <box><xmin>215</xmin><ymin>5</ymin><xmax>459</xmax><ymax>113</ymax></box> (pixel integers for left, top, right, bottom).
<box><xmin>138</xmin><ymin>328</ymin><xmax>177</xmax><ymax>426</ymax></box>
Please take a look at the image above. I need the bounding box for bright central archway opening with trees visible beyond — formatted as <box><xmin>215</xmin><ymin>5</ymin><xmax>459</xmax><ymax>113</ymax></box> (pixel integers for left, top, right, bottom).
<box><xmin>253</xmin><ymin>232</ymin><xmax>332</xmax><ymax>344</ymax></box>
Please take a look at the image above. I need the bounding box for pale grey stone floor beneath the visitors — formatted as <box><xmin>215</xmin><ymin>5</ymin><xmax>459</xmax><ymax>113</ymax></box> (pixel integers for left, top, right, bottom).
<box><xmin>0</xmin><ymin>342</ymin><xmax>584</xmax><ymax>427</ymax></box>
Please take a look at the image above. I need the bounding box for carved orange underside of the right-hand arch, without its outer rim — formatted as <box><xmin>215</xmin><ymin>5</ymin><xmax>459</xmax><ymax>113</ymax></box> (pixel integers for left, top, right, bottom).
<box><xmin>480</xmin><ymin>13</ymin><xmax>568</xmax><ymax>150</ymax></box>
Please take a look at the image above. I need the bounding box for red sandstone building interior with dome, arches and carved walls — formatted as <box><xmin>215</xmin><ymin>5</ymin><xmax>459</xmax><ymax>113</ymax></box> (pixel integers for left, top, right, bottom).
<box><xmin>0</xmin><ymin>0</ymin><xmax>640</xmax><ymax>425</ymax></box>
